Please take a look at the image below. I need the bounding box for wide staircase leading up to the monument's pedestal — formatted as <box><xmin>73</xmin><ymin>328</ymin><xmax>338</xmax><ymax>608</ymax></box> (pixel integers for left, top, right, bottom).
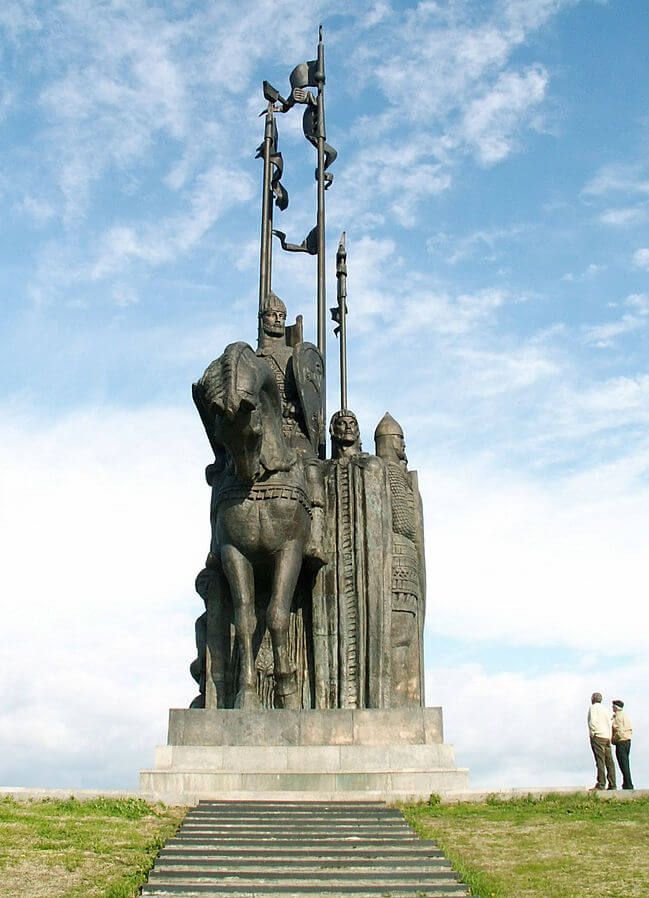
<box><xmin>142</xmin><ymin>801</ymin><xmax>469</xmax><ymax>898</ymax></box>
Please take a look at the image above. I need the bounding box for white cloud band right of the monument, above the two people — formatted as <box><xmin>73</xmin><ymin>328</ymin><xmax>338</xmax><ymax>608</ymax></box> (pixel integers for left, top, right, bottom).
<box><xmin>420</xmin><ymin>450</ymin><xmax>649</xmax><ymax>655</ymax></box>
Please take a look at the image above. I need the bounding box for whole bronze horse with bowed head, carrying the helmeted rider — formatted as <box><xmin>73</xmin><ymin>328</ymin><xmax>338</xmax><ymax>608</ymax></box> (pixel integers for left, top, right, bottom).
<box><xmin>192</xmin><ymin>342</ymin><xmax>311</xmax><ymax>710</ymax></box>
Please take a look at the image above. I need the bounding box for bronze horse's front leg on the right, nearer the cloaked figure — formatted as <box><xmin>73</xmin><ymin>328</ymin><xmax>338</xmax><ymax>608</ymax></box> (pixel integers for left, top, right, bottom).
<box><xmin>266</xmin><ymin>540</ymin><xmax>303</xmax><ymax>709</ymax></box>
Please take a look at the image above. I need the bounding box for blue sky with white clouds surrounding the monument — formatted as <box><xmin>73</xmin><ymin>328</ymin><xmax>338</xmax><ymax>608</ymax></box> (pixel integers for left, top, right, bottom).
<box><xmin>0</xmin><ymin>0</ymin><xmax>649</xmax><ymax>789</ymax></box>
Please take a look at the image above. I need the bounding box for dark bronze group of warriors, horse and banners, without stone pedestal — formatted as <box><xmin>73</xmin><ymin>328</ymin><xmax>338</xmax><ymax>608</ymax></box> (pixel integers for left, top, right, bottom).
<box><xmin>191</xmin><ymin>34</ymin><xmax>425</xmax><ymax>710</ymax></box>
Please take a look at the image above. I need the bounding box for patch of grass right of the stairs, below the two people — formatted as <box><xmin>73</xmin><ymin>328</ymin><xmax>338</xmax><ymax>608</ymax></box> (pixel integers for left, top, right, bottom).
<box><xmin>402</xmin><ymin>794</ymin><xmax>649</xmax><ymax>898</ymax></box>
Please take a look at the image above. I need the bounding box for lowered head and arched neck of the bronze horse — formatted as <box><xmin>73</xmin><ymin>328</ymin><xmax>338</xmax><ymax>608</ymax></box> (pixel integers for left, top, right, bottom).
<box><xmin>193</xmin><ymin>343</ymin><xmax>295</xmax><ymax>483</ymax></box>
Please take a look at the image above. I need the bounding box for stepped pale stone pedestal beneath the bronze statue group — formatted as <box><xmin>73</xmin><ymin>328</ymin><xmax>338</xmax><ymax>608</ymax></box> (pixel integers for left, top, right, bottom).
<box><xmin>140</xmin><ymin>708</ymin><xmax>469</xmax><ymax>804</ymax></box>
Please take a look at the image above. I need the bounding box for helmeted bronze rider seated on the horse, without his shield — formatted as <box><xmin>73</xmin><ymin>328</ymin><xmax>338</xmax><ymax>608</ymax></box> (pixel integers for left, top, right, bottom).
<box><xmin>257</xmin><ymin>290</ymin><xmax>327</xmax><ymax>564</ymax></box>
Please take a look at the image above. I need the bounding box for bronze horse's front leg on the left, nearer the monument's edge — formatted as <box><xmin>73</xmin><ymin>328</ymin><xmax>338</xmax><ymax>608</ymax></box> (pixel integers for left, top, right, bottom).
<box><xmin>221</xmin><ymin>545</ymin><xmax>260</xmax><ymax>710</ymax></box>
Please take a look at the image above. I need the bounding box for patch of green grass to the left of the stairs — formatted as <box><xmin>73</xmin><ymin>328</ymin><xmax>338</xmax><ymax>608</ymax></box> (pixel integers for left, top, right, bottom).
<box><xmin>0</xmin><ymin>798</ymin><xmax>186</xmax><ymax>898</ymax></box>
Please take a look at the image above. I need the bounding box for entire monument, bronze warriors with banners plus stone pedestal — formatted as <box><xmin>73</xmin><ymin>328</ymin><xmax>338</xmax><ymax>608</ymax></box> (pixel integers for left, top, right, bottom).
<box><xmin>140</xmin><ymin>26</ymin><xmax>468</xmax><ymax>804</ymax></box>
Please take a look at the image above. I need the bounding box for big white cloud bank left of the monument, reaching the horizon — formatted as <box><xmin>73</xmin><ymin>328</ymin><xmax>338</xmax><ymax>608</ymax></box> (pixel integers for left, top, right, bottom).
<box><xmin>0</xmin><ymin>407</ymin><xmax>209</xmax><ymax>788</ymax></box>
